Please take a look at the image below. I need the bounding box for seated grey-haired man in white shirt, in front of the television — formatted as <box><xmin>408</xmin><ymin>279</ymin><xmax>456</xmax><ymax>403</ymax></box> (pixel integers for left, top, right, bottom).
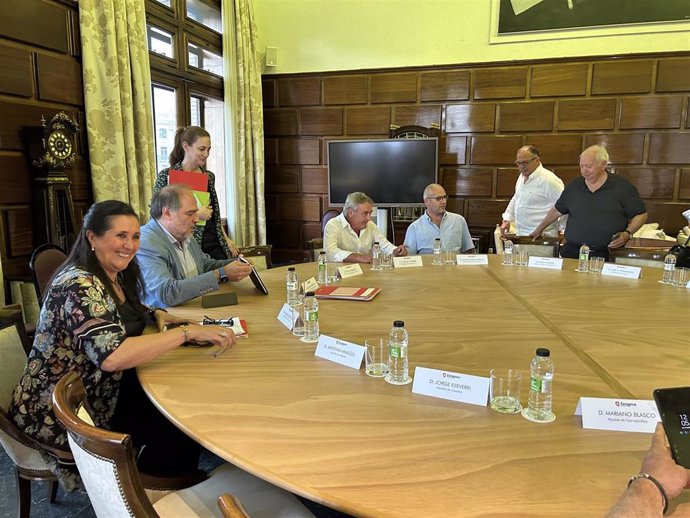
<box><xmin>323</xmin><ymin>192</ymin><xmax>407</xmax><ymax>263</ymax></box>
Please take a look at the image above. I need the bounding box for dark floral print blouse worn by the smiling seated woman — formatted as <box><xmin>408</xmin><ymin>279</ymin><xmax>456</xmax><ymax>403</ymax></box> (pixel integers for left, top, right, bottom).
<box><xmin>9</xmin><ymin>266</ymin><xmax>127</xmax><ymax>456</ymax></box>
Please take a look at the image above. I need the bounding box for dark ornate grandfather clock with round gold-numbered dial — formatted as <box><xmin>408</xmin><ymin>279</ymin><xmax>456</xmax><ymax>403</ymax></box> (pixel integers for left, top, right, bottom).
<box><xmin>23</xmin><ymin>112</ymin><xmax>79</xmax><ymax>250</ymax></box>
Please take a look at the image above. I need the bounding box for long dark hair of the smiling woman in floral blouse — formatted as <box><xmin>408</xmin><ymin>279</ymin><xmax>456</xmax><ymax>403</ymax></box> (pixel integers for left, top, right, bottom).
<box><xmin>54</xmin><ymin>200</ymin><xmax>144</xmax><ymax>306</ymax></box>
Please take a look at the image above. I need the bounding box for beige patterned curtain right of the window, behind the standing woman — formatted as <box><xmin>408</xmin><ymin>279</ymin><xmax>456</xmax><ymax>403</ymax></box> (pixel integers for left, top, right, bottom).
<box><xmin>222</xmin><ymin>0</ymin><xmax>266</xmax><ymax>245</ymax></box>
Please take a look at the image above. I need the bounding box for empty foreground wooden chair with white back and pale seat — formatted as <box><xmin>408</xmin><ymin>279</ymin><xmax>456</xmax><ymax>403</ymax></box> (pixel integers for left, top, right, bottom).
<box><xmin>53</xmin><ymin>373</ymin><xmax>313</xmax><ymax>518</ymax></box>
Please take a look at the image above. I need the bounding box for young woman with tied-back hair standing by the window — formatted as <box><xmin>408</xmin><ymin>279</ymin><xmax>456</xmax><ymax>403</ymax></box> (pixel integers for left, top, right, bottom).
<box><xmin>154</xmin><ymin>126</ymin><xmax>239</xmax><ymax>260</ymax></box>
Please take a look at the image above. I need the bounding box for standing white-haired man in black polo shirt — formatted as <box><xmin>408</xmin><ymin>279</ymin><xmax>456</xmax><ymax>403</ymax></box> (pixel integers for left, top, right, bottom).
<box><xmin>530</xmin><ymin>146</ymin><xmax>647</xmax><ymax>260</ymax></box>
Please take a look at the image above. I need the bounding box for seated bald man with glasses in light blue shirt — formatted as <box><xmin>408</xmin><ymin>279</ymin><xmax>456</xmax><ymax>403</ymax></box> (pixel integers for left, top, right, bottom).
<box><xmin>405</xmin><ymin>183</ymin><xmax>474</xmax><ymax>254</ymax></box>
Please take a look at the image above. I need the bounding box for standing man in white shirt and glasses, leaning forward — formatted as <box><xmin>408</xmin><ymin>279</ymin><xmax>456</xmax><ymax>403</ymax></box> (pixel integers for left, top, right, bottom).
<box><xmin>501</xmin><ymin>146</ymin><xmax>567</xmax><ymax>237</ymax></box>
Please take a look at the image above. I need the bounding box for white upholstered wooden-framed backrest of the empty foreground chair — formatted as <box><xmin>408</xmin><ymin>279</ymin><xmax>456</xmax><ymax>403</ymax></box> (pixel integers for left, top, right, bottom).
<box><xmin>53</xmin><ymin>372</ymin><xmax>158</xmax><ymax>518</ymax></box>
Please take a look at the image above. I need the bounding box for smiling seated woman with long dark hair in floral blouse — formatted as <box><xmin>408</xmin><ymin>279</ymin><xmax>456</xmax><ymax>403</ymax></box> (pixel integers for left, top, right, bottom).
<box><xmin>9</xmin><ymin>200</ymin><xmax>235</xmax><ymax>490</ymax></box>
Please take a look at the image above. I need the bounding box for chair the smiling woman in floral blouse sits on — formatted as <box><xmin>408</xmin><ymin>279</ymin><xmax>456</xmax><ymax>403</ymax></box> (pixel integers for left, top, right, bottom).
<box><xmin>0</xmin><ymin>306</ymin><xmax>63</xmax><ymax>518</ymax></box>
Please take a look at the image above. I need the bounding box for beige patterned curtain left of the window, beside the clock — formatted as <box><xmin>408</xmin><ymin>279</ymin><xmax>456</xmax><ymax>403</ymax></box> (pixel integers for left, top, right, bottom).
<box><xmin>79</xmin><ymin>0</ymin><xmax>156</xmax><ymax>223</ymax></box>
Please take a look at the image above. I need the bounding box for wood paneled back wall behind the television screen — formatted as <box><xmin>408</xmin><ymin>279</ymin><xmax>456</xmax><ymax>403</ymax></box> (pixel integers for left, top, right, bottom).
<box><xmin>263</xmin><ymin>53</ymin><xmax>690</xmax><ymax>260</ymax></box>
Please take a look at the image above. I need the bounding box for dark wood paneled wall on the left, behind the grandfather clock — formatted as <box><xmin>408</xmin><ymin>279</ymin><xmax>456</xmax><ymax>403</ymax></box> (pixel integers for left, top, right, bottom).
<box><xmin>0</xmin><ymin>0</ymin><xmax>93</xmax><ymax>284</ymax></box>
